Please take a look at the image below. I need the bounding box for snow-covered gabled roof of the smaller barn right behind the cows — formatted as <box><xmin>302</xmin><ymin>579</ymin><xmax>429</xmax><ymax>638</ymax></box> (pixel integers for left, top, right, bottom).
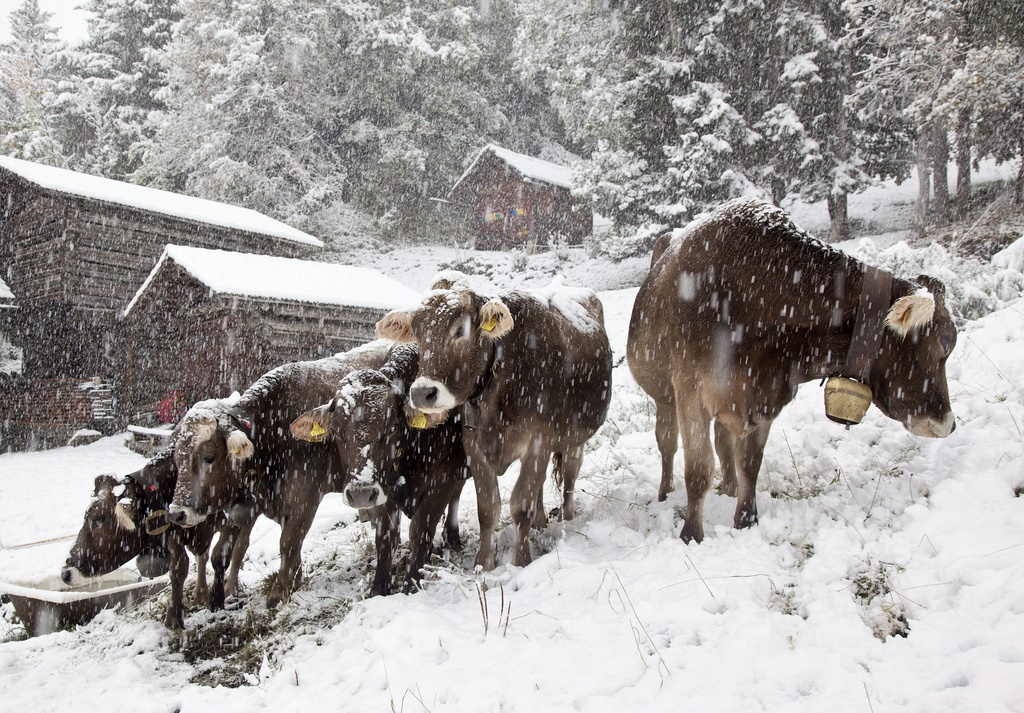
<box><xmin>124</xmin><ymin>245</ymin><xmax>420</xmax><ymax>316</ymax></box>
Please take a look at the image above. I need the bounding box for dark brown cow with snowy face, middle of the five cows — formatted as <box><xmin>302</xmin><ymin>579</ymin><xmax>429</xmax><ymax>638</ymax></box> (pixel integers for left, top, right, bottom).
<box><xmin>292</xmin><ymin>345</ymin><xmax>469</xmax><ymax>594</ymax></box>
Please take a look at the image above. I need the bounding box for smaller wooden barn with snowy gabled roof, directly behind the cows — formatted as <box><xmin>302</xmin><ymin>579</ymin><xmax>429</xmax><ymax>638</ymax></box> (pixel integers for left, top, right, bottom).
<box><xmin>118</xmin><ymin>245</ymin><xmax>420</xmax><ymax>421</ymax></box>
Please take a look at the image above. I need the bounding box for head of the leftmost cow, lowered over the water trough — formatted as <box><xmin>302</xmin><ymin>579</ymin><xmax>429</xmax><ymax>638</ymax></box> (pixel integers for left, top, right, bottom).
<box><xmin>60</xmin><ymin>473</ymin><xmax>147</xmax><ymax>586</ymax></box>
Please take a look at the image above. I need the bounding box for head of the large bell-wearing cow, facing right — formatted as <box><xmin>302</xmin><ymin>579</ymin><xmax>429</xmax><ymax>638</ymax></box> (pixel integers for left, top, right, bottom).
<box><xmin>870</xmin><ymin>276</ymin><xmax>956</xmax><ymax>438</ymax></box>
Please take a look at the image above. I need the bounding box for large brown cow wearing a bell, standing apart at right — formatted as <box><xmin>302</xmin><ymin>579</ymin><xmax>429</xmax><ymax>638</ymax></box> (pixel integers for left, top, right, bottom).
<box><xmin>627</xmin><ymin>199</ymin><xmax>956</xmax><ymax>542</ymax></box>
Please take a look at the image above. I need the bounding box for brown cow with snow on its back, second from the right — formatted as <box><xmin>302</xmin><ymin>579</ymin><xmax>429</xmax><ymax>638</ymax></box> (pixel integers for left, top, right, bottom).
<box><xmin>377</xmin><ymin>276</ymin><xmax>611</xmax><ymax>570</ymax></box>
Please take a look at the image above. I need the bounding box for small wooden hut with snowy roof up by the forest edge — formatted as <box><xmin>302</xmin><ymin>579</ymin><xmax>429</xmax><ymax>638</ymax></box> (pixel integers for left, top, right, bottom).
<box><xmin>449</xmin><ymin>143</ymin><xmax>594</xmax><ymax>250</ymax></box>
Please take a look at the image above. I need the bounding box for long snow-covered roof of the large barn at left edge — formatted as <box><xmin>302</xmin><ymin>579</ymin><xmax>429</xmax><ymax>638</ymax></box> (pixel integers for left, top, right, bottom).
<box><xmin>0</xmin><ymin>156</ymin><xmax>324</xmax><ymax>248</ymax></box>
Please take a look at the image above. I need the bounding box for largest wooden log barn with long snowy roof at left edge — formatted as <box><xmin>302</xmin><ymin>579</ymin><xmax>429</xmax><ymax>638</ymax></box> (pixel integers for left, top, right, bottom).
<box><xmin>0</xmin><ymin>157</ymin><xmax>323</xmax><ymax>448</ymax></box>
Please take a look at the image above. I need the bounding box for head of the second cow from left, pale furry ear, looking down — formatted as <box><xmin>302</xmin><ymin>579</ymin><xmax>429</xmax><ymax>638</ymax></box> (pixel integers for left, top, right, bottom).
<box><xmin>168</xmin><ymin>403</ymin><xmax>255</xmax><ymax>528</ymax></box>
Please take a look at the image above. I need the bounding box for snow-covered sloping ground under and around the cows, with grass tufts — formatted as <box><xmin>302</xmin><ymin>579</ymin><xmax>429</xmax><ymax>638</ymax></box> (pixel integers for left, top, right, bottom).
<box><xmin>0</xmin><ymin>168</ymin><xmax>1024</xmax><ymax>713</ymax></box>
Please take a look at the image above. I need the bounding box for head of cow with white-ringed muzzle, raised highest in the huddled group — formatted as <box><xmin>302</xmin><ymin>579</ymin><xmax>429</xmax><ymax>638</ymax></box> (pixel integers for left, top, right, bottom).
<box><xmin>377</xmin><ymin>279</ymin><xmax>515</xmax><ymax>413</ymax></box>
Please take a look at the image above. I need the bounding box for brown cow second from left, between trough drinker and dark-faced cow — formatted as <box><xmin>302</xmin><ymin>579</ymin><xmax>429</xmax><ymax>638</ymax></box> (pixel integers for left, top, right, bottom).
<box><xmin>172</xmin><ymin>340</ymin><xmax>454</xmax><ymax>606</ymax></box>
